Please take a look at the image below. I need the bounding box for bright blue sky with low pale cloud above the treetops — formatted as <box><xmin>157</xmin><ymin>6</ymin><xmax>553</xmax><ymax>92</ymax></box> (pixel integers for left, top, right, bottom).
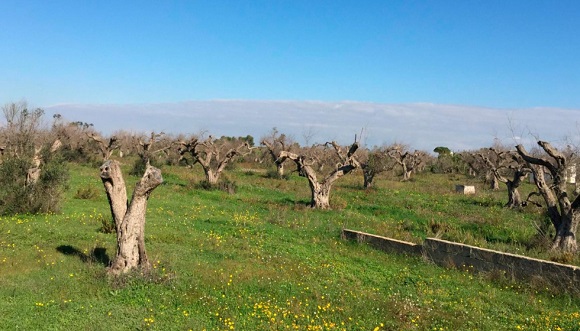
<box><xmin>0</xmin><ymin>0</ymin><xmax>580</xmax><ymax>148</ymax></box>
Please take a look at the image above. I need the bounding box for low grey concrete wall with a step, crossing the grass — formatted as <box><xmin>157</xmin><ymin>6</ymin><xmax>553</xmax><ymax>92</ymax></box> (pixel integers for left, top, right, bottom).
<box><xmin>342</xmin><ymin>229</ymin><xmax>580</xmax><ymax>292</ymax></box>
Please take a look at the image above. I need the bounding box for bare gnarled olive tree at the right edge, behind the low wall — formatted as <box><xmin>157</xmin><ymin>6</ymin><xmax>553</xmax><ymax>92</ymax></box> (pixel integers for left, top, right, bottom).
<box><xmin>516</xmin><ymin>141</ymin><xmax>580</xmax><ymax>253</ymax></box>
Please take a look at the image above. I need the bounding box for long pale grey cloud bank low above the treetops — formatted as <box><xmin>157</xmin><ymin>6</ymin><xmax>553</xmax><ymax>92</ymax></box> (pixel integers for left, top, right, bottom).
<box><xmin>44</xmin><ymin>100</ymin><xmax>580</xmax><ymax>151</ymax></box>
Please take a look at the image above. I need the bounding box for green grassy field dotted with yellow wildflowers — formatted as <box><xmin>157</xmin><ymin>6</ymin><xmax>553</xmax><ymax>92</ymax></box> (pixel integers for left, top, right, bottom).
<box><xmin>0</xmin><ymin>165</ymin><xmax>580</xmax><ymax>330</ymax></box>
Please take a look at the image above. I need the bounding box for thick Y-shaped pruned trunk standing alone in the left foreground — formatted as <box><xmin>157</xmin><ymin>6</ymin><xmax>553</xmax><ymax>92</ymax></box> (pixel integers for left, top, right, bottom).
<box><xmin>100</xmin><ymin>160</ymin><xmax>163</xmax><ymax>275</ymax></box>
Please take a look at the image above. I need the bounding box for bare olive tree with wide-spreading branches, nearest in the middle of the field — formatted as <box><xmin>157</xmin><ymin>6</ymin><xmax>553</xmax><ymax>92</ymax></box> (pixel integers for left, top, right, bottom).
<box><xmin>276</xmin><ymin>141</ymin><xmax>360</xmax><ymax>209</ymax></box>
